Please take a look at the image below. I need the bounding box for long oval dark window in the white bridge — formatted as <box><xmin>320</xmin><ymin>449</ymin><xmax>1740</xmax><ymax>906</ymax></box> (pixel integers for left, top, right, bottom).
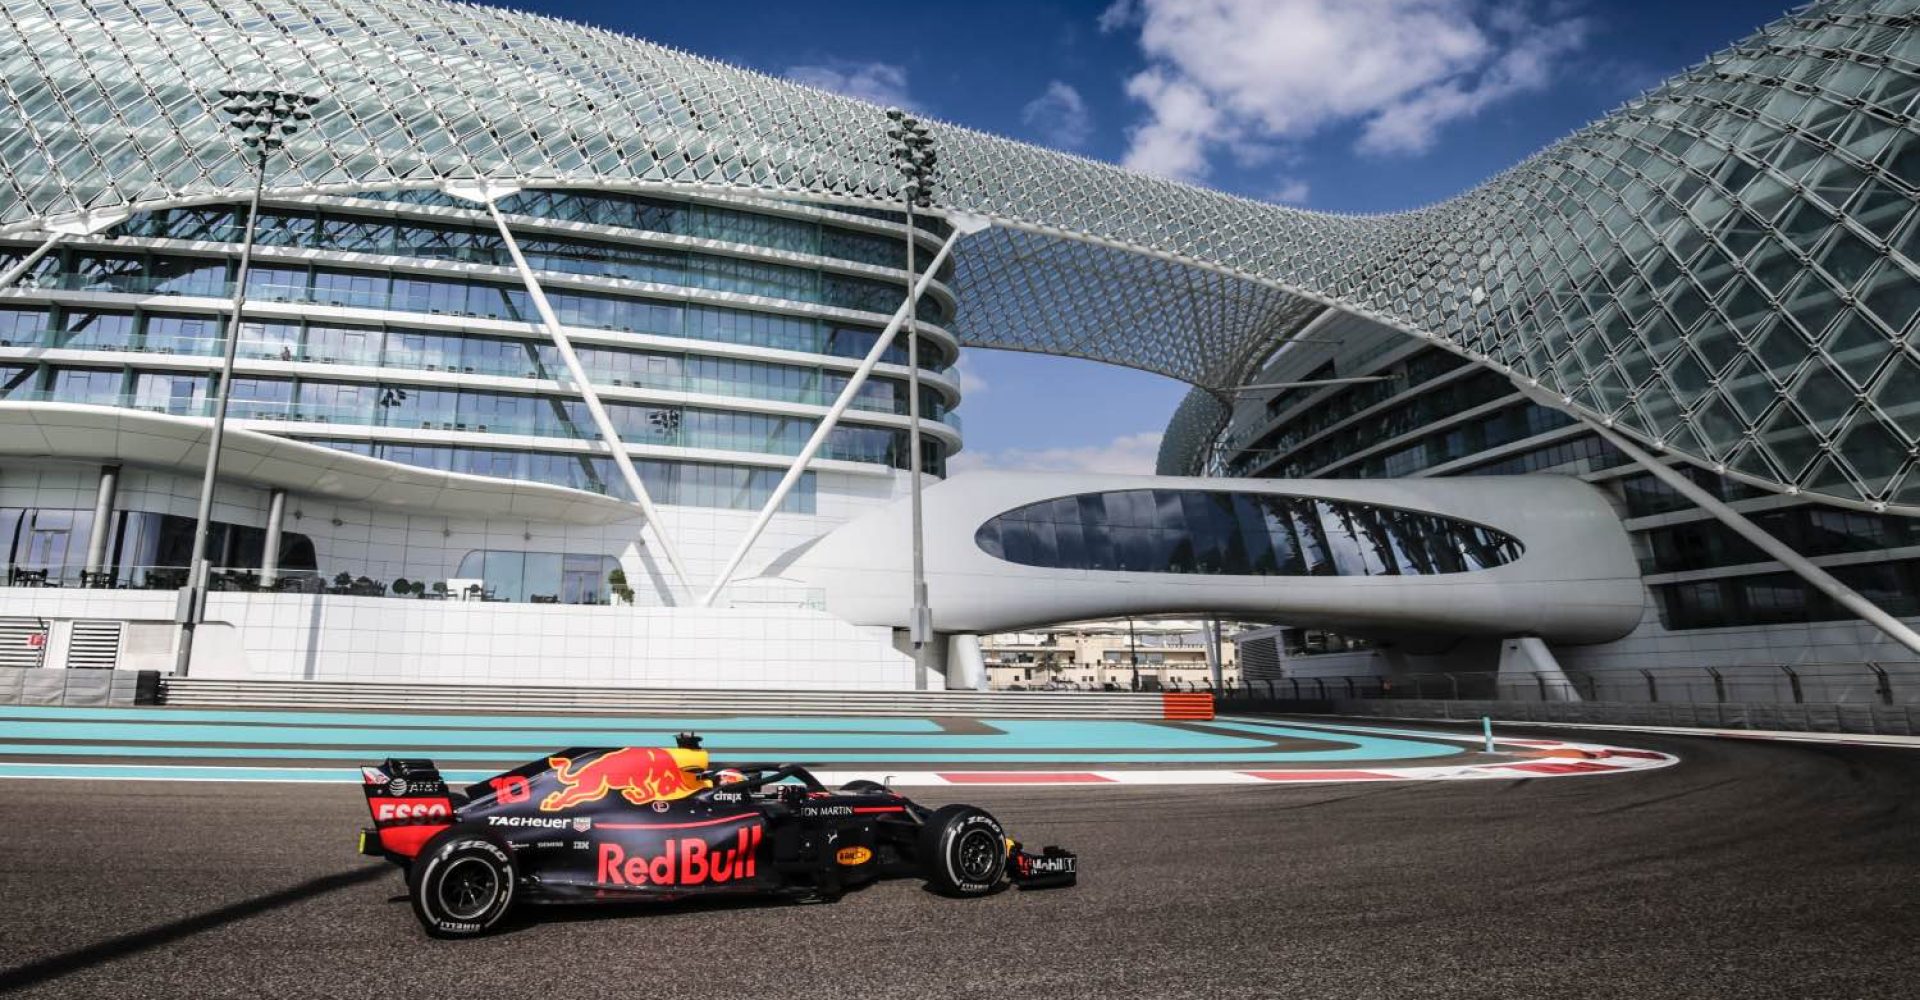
<box><xmin>973</xmin><ymin>489</ymin><xmax>1521</xmax><ymax>576</ymax></box>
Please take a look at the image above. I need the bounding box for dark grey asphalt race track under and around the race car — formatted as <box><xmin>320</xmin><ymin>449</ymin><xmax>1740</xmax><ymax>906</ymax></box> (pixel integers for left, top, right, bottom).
<box><xmin>0</xmin><ymin>731</ymin><xmax>1920</xmax><ymax>1000</ymax></box>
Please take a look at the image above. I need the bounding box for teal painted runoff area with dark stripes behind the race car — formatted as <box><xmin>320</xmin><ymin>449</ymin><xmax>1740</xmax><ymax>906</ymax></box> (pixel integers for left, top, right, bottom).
<box><xmin>0</xmin><ymin>706</ymin><xmax>1463</xmax><ymax>781</ymax></box>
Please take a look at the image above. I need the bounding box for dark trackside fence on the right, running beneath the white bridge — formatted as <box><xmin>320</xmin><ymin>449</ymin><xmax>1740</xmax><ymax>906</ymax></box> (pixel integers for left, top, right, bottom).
<box><xmin>1219</xmin><ymin>660</ymin><xmax>1920</xmax><ymax>706</ymax></box>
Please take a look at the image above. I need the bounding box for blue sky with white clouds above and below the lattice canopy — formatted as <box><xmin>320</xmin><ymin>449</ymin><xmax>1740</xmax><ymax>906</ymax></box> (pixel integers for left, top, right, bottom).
<box><xmin>509</xmin><ymin>0</ymin><xmax>1784</xmax><ymax>472</ymax></box>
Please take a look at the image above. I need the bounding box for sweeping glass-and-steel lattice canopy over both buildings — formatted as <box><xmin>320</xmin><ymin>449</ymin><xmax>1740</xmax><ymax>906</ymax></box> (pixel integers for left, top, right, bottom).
<box><xmin>0</xmin><ymin>0</ymin><xmax>1920</xmax><ymax>512</ymax></box>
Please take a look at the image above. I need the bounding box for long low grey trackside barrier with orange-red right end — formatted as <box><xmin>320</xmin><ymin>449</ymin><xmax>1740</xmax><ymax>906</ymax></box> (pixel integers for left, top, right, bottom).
<box><xmin>145</xmin><ymin>670</ymin><xmax>1213</xmax><ymax>722</ymax></box>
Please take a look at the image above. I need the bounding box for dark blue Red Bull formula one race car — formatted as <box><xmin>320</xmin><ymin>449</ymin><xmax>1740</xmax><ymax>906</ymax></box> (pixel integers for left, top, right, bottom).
<box><xmin>361</xmin><ymin>735</ymin><xmax>1075</xmax><ymax>937</ymax></box>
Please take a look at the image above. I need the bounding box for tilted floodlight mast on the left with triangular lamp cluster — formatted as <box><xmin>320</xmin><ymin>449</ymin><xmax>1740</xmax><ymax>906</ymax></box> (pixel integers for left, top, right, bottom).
<box><xmin>173</xmin><ymin>88</ymin><xmax>321</xmax><ymax>678</ymax></box>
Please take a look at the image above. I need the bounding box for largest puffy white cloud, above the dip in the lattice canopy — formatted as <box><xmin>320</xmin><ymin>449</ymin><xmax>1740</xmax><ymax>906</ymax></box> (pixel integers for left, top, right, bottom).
<box><xmin>1100</xmin><ymin>0</ymin><xmax>1588</xmax><ymax>179</ymax></box>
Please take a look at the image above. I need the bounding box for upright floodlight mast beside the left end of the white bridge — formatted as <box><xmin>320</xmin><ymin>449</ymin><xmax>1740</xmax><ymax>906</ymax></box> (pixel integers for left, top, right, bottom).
<box><xmin>887</xmin><ymin>107</ymin><xmax>939</xmax><ymax>691</ymax></box>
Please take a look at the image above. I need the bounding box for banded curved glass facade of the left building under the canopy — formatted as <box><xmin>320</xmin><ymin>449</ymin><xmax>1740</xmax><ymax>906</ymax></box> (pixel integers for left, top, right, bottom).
<box><xmin>0</xmin><ymin>181</ymin><xmax>958</xmax><ymax>499</ymax></box>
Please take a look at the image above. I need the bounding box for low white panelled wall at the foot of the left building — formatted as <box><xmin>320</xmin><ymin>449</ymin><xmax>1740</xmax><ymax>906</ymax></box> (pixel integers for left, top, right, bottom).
<box><xmin>0</xmin><ymin>587</ymin><xmax>914</xmax><ymax>691</ymax></box>
